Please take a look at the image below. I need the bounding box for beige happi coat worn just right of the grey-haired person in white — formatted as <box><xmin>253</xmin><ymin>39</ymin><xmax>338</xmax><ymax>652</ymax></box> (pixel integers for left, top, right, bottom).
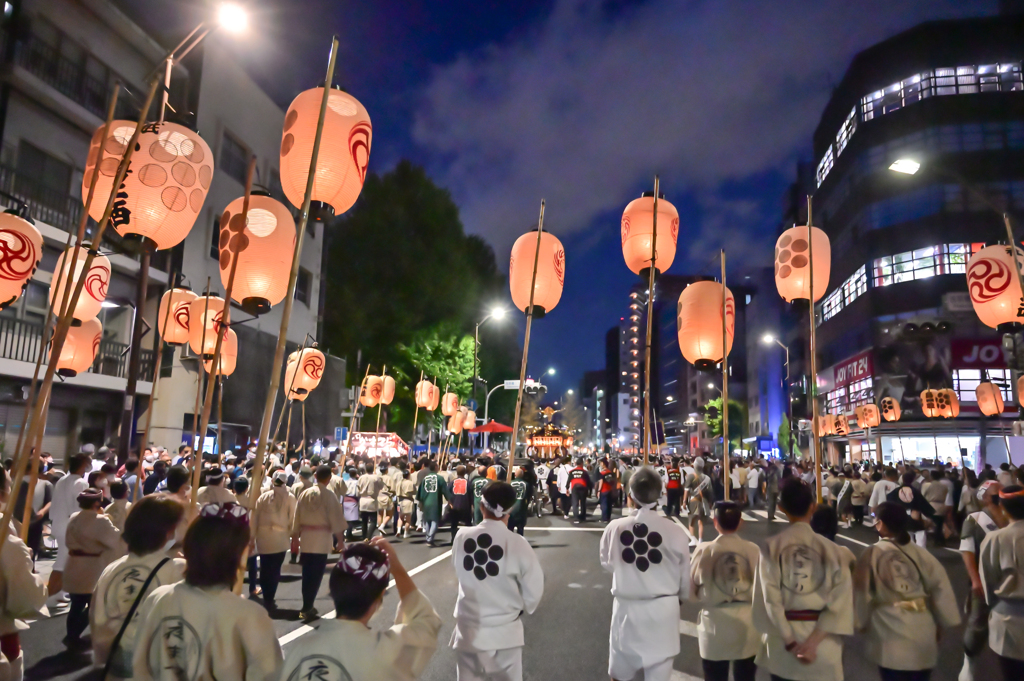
<box><xmin>690</xmin><ymin>534</ymin><xmax>761</xmax><ymax>659</ymax></box>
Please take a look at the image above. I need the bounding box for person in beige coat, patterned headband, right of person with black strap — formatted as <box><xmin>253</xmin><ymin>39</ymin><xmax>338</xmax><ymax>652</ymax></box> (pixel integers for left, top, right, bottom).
<box><xmin>132</xmin><ymin>504</ymin><xmax>284</xmax><ymax>681</ymax></box>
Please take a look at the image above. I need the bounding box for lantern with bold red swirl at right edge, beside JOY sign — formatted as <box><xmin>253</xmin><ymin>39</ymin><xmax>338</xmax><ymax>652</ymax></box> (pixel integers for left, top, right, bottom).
<box><xmin>967</xmin><ymin>246</ymin><xmax>1024</xmax><ymax>329</ymax></box>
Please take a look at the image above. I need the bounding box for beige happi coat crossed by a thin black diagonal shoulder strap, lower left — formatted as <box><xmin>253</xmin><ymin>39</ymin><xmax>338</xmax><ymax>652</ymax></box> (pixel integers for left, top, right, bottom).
<box><xmin>89</xmin><ymin>551</ymin><xmax>185</xmax><ymax>679</ymax></box>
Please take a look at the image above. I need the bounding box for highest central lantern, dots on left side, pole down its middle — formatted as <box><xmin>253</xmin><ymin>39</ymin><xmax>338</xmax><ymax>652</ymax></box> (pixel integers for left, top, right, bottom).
<box><xmin>622</xmin><ymin>193</ymin><xmax>679</xmax><ymax>276</ymax></box>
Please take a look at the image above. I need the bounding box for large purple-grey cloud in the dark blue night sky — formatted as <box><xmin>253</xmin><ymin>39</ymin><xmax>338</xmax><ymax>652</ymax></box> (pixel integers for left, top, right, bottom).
<box><xmin>413</xmin><ymin>0</ymin><xmax>994</xmax><ymax>260</ymax></box>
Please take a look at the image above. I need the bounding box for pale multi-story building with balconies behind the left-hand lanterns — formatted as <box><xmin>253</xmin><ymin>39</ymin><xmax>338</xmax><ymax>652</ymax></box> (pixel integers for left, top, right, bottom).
<box><xmin>0</xmin><ymin>0</ymin><xmax>335</xmax><ymax>457</ymax></box>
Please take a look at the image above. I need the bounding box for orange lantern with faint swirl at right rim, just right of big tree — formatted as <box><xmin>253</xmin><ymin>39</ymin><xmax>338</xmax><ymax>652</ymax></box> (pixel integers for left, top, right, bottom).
<box><xmin>509</xmin><ymin>229</ymin><xmax>565</xmax><ymax>318</ymax></box>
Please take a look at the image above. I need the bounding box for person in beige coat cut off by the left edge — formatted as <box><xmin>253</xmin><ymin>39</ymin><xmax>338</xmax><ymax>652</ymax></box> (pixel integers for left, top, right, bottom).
<box><xmin>0</xmin><ymin>466</ymin><xmax>49</xmax><ymax>681</ymax></box>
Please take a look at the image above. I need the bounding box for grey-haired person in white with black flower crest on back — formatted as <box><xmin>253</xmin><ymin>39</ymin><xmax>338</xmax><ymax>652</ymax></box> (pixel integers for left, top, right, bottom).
<box><xmin>601</xmin><ymin>466</ymin><xmax>690</xmax><ymax>681</ymax></box>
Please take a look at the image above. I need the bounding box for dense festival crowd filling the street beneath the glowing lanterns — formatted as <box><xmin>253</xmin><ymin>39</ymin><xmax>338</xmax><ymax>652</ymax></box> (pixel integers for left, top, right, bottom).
<box><xmin>0</xmin><ymin>445</ymin><xmax>1024</xmax><ymax>681</ymax></box>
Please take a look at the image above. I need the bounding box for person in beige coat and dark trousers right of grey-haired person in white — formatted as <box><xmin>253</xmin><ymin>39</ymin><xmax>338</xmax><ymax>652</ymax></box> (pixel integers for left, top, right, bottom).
<box><xmin>690</xmin><ymin>502</ymin><xmax>761</xmax><ymax>681</ymax></box>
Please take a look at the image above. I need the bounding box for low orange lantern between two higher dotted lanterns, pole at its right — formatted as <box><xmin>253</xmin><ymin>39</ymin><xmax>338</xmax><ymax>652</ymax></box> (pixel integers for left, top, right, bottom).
<box><xmin>676</xmin><ymin>282</ymin><xmax>736</xmax><ymax>371</ymax></box>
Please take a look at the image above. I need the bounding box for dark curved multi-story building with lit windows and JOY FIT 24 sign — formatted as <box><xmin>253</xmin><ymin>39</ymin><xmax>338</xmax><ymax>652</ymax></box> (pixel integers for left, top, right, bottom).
<box><xmin>813</xmin><ymin>12</ymin><xmax>1024</xmax><ymax>465</ymax></box>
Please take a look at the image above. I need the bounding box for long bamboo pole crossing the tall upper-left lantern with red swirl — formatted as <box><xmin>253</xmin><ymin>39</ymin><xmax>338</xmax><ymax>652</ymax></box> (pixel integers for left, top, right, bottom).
<box><xmin>250</xmin><ymin>36</ymin><xmax>338</xmax><ymax>507</ymax></box>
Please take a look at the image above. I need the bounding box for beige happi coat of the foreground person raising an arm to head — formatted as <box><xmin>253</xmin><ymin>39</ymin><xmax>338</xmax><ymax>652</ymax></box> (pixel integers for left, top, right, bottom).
<box><xmin>281</xmin><ymin>590</ymin><xmax>441</xmax><ymax>681</ymax></box>
